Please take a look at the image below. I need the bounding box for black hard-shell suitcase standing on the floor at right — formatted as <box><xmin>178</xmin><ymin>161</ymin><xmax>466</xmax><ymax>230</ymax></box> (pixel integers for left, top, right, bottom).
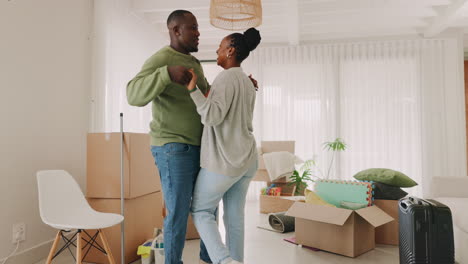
<box><xmin>398</xmin><ymin>197</ymin><xmax>455</xmax><ymax>264</ymax></box>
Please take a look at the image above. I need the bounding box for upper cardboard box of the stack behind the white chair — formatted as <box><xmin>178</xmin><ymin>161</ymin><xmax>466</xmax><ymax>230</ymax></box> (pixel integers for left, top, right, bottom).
<box><xmin>86</xmin><ymin>133</ymin><xmax>161</xmax><ymax>199</ymax></box>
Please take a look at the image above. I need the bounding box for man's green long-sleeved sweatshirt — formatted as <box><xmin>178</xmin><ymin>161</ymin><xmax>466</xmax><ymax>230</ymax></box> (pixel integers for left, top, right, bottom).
<box><xmin>127</xmin><ymin>46</ymin><xmax>209</xmax><ymax>146</ymax></box>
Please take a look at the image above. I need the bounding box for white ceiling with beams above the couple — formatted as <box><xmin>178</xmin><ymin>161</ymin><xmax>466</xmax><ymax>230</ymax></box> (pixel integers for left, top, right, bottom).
<box><xmin>132</xmin><ymin>0</ymin><xmax>468</xmax><ymax>58</ymax></box>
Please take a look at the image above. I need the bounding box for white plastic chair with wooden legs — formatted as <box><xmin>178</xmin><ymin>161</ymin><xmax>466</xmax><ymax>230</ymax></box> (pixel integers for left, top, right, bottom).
<box><xmin>37</xmin><ymin>170</ymin><xmax>124</xmax><ymax>264</ymax></box>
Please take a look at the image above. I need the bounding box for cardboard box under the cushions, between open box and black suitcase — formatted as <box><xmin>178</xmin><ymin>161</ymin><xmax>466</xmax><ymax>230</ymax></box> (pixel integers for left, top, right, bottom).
<box><xmin>374</xmin><ymin>200</ymin><xmax>400</xmax><ymax>246</ymax></box>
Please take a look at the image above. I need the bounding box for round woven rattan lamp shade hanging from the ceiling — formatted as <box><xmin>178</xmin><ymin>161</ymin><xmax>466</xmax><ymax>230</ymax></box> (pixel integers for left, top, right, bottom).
<box><xmin>210</xmin><ymin>0</ymin><xmax>262</xmax><ymax>30</ymax></box>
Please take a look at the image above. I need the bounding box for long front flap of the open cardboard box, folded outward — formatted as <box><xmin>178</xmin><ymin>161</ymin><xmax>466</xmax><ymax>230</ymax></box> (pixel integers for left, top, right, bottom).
<box><xmin>286</xmin><ymin>202</ymin><xmax>353</xmax><ymax>225</ymax></box>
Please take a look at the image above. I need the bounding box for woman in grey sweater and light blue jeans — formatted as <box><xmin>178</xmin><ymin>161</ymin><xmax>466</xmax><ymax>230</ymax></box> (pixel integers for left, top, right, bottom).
<box><xmin>187</xmin><ymin>28</ymin><xmax>261</xmax><ymax>264</ymax></box>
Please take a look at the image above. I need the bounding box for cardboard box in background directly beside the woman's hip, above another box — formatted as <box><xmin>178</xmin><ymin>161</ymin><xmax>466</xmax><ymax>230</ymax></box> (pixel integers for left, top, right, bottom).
<box><xmin>252</xmin><ymin>141</ymin><xmax>295</xmax><ymax>182</ymax></box>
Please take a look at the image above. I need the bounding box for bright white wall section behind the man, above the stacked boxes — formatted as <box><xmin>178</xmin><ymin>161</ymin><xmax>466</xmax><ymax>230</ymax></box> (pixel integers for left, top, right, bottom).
<box><xmin>90</xmin><ymin>0</ymin><xmax>165</xmax><ymax>133</ymax></box>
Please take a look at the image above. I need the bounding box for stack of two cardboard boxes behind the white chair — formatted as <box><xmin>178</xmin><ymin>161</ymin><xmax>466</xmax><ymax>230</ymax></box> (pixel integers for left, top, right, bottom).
<box><xmin>83</xmin><ymin>133</ymin><xmax>163</xmax><ymax>263</ymax></box>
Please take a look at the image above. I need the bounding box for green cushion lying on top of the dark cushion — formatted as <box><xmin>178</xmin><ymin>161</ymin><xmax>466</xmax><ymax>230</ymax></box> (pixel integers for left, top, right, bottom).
<box><xmin>354</xmin><ymin>168</ymin><xmax>418</xmax><ymax>187</ymax></box>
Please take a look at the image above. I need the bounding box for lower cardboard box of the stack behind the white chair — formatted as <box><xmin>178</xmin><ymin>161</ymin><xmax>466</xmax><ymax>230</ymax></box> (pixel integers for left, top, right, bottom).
<box><xmin>83</xmin><ymin>192</ymin><xmax>163</xmax><ymax>263</ymax></box>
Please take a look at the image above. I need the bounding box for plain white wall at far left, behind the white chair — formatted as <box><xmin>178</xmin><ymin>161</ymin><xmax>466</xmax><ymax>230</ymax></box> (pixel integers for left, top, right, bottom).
<box><xmin>0</xmin><ymin>0</ymin><xmax>92</xmax><ymax>261</ymax></box>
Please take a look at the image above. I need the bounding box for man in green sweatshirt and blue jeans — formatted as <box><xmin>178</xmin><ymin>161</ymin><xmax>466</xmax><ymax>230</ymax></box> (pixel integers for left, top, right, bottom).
<box><xmin>127</xmin><ymin>10</ymin><xmax>211</xmax><ymax>264</ymax></box>
